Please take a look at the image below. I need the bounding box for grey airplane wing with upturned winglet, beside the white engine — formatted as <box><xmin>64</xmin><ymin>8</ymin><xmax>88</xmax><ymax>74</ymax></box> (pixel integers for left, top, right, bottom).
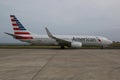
<box><xmin>45</xmin><ymin>28</ymin><xmax>72</xmax><ymax>46</ymax></box>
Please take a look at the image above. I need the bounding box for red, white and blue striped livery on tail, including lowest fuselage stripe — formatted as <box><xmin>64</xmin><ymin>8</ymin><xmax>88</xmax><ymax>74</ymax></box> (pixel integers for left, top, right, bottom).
<box><xmin>10</xmin><ymin>15</ymin><xmax>33</xmax><ymax>39</ymax></box>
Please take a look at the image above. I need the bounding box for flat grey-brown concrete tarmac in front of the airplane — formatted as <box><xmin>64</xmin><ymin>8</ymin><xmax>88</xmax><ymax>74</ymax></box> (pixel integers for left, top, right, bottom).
<box><xmin>0</xmin><ymin>49</ymin><xmax>120</xmax><ymax>80</ymax></box>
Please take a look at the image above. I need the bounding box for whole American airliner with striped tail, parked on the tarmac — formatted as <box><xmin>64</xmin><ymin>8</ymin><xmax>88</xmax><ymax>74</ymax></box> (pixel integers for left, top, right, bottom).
<box><xmin>5</xmin><ymin>15</ymin><xmax>112</xmax><ymax>48</ymax></box>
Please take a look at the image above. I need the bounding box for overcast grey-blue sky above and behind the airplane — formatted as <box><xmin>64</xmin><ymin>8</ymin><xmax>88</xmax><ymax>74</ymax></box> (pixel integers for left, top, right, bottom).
<box><xmin>0</xmin><ymin>0</ymin><xmax>120</xmax><ymax>43</ymax></box>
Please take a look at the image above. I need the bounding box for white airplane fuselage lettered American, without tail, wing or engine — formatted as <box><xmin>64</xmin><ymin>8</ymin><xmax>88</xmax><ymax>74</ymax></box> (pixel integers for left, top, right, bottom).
<box><xmin>21</xmin><ymin>35</ymin><xmax>112</xmax><ymax>46</ymax></box>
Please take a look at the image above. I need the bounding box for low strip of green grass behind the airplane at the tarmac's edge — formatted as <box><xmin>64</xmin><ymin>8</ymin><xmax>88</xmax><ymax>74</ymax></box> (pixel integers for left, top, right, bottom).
<box><xmin>0</xmin><ymin>42</ymin><xmax>120</xmax><ymax>49</ymax></box>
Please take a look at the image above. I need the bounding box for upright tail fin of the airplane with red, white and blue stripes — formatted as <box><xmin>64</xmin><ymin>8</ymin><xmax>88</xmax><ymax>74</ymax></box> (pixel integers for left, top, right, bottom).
<box><xmin>10</xmin><ymin>15</ymin><xmax>30</xmax><ymax>35</ymax></box>
